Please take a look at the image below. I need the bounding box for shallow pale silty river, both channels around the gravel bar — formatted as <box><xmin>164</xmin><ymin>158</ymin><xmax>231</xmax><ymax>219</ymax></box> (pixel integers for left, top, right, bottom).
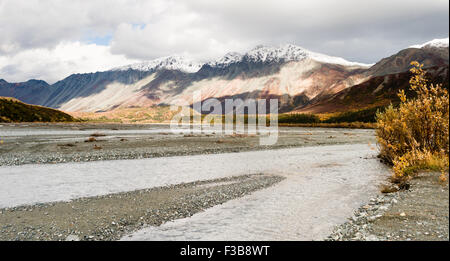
<box><xmin>0</xmin><ymin>144</ymin><xmax>389</xmax><ymax>240</ymax></box>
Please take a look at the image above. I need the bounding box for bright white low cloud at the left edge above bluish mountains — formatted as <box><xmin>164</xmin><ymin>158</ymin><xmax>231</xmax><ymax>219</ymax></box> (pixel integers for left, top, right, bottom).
<box><xmin>0</xmin><ymin>42</ymin><xmax>137</xmax><ymax>83</ymax></box>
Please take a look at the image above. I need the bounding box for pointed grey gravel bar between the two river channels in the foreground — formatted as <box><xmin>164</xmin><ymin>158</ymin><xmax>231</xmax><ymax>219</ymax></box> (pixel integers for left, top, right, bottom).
<box><xmin>0</xmin><ymin>174</ymin><xmax>283</xmax><ymax>241</ymax></box>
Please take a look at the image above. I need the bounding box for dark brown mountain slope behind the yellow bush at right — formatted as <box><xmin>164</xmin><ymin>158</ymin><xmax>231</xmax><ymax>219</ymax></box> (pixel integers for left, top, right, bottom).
<box><xmin>294</xmin><ymin>38</ymin><xmax>449</xmax><ymax>113</ymax></box>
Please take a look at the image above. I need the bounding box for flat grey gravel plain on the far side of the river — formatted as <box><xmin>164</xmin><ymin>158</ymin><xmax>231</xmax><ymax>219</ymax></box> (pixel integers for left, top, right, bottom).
<box><xmin>0</xmin><ymin>123</ymin><xmax>375</xmax><ymax>166</ymax></box>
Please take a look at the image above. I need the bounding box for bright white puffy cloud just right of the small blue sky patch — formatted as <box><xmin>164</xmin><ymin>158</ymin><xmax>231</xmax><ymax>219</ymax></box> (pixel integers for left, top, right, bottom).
<box><xmin>111</xmin><ymin>13</ymin><xmax>250</xmax><ymax>61</ymax></box>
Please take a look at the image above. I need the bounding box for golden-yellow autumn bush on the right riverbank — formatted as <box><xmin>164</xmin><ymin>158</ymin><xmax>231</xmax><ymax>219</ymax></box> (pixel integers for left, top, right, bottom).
<box><xmin>376</xmin><ymin>62</ymin><xmax>449</xmax><ymax>181</ymax></box>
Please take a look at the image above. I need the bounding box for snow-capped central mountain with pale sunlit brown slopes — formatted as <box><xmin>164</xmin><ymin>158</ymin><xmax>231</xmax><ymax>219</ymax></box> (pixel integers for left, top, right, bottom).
<box><xmin>51</xmin><ymin>44</ymin><xmax>370</xmax><ymax>111</ymax></box>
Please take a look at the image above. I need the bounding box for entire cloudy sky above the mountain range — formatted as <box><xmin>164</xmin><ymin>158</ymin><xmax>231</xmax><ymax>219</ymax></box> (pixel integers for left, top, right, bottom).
<box><xmin>0</xmin><ymin>0</ymin><xmax>449</xmax><ymax>83</ymax></box>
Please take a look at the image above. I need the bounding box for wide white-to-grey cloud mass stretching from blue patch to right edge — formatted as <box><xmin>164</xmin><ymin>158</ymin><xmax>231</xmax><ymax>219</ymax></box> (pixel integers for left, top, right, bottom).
<box><xmin>112</xmin><ymin>0</ymin><xmax>449</xmax><ymax>63</ymax></box>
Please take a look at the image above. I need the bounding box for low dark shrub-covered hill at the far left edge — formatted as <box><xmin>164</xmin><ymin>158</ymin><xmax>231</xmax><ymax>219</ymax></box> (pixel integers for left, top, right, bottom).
<box><xmin>0</xmin><ymin>97</ymin><xmax>75</xmax><ymax>122</ymax></box>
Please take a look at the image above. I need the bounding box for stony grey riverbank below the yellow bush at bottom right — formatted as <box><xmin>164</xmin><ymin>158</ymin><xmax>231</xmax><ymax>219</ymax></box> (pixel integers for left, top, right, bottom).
<box><xmin>325</xmin><ymin>173</ymin><xmax>449</xmax><ymax>241</ymax></box>
